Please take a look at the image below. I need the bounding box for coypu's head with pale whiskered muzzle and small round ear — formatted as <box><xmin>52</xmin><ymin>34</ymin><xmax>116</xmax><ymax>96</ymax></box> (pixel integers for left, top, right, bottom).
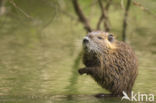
<box><xmin>83</xmin><ymin>31</ymin><xmax>116</xmax><ymax>53</ymax></box>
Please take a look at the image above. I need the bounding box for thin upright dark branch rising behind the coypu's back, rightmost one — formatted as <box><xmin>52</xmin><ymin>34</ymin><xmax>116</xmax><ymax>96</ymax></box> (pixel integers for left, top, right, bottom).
<box><xmin>122</xmin><ymin>0</ymin><xmax>132</xmax><ymax>41</ymax></box>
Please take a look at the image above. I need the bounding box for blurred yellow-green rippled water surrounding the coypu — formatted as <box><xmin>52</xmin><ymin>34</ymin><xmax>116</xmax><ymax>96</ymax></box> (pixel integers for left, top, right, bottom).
<box><xmin>0</xmin><ymin>1</ymin><xmax>156</xmax><ymax>103</ymax></box>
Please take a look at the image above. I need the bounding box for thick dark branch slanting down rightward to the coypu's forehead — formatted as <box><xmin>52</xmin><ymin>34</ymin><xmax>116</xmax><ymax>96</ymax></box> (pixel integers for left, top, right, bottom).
<box><xmin>72</xmin><ymin>0</ymin><xmax>92</xmax><ymax>32</ymax></box>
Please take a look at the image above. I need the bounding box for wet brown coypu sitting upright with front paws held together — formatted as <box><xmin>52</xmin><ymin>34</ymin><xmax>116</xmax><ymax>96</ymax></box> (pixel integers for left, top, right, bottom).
<box><xmin>79</xmin><ymin>31</ymin><xmax>138</xmax><ymax>96</ymax></box>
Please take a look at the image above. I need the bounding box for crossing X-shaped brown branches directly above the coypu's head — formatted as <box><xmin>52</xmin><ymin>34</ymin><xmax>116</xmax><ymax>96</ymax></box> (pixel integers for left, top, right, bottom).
<box><xmin>97</xmin><ymin>0</ymin><xmax>112</xmax><ymax>31</ymax></box>
